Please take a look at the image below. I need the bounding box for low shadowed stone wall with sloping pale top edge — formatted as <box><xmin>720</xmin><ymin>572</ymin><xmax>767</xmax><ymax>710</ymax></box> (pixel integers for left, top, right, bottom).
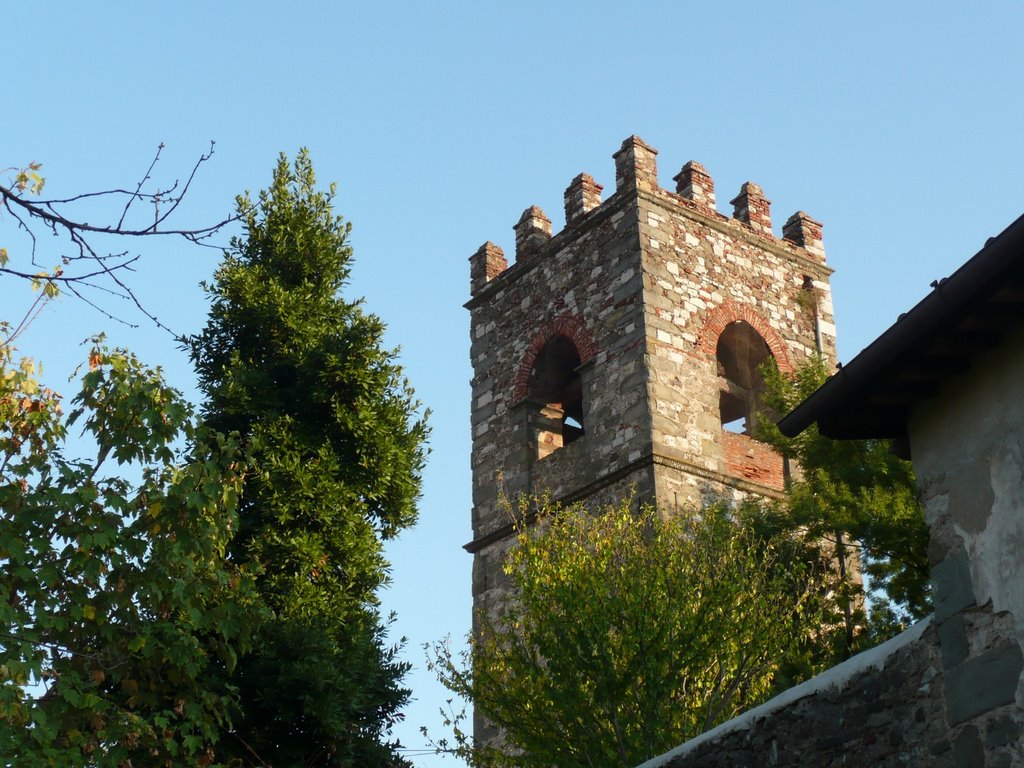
<box><xmin>641</xmin><ymin>620</ymin><xmax>1020</xmax><ymax>768</ymax></box>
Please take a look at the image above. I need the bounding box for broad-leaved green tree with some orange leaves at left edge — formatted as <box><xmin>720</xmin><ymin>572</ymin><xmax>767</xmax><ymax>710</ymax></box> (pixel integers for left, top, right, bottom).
<box><xmin>0</xmin><ymin>345</ymin><xmax>254</xmax><ymax>766</ymax></box>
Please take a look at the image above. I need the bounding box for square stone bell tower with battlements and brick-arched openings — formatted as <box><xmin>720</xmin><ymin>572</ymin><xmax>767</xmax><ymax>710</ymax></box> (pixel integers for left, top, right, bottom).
<box><xmin>466</xmin><ymin>136</ymin><xmax>836</xmax><ymax>609</ymax></box>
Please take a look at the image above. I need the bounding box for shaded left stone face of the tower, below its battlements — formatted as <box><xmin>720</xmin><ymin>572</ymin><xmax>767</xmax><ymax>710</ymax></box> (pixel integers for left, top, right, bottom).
<box><xmin>468</xmin><ymin>178</ymin><xmax>649</xmax><ymax>539</ymax></box>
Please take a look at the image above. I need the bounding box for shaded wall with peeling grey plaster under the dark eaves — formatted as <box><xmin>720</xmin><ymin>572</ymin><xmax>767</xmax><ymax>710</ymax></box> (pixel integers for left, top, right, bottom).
<box><xmin>909</xmin><ymin>325</ymin><xmax>1024</xmax><ymax>765</ymax></box>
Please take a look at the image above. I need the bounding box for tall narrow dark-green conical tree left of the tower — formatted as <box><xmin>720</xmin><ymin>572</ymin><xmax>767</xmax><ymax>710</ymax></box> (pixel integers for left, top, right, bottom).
<box><xmin>189</xmin><ymin>151</ymin><xmax>427</xmax><ymax>766</ymax></box>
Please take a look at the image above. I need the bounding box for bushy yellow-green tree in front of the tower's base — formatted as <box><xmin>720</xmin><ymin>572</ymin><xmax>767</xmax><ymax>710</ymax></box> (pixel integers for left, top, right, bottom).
<box><xmin>429</xmin><ymin>500</ymin><xmax>817</xmax><ymax>768</ymax></box>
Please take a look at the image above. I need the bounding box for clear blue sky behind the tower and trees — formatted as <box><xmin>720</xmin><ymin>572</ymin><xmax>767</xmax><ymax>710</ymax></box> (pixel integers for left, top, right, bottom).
<box><xmin>6</xmin><ymin>0</ymin><xmax>1024</xmax><ymax>766</ymax></box>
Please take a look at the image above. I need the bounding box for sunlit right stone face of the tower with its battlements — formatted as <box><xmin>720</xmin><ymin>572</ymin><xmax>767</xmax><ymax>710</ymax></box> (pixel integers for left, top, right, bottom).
<box><xmin>624</xmin><ymin>140</ymin><xmax>836</xmax><ymax>502</ymax></box>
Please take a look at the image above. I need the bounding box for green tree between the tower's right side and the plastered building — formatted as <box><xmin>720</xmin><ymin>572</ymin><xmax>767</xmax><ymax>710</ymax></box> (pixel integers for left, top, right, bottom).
<box><xmin>758</xmin><ymin>359</ymin><xmax>932</xmax><ymax>638</ymax></box>
